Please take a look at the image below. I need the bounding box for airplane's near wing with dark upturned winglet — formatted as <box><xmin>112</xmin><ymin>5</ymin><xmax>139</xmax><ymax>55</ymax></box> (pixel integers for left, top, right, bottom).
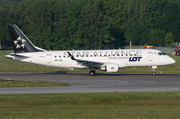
<box><xmin>68</xmin><ymin>52</ymin><xmax>104</xmax><ymax>68</ymax></box>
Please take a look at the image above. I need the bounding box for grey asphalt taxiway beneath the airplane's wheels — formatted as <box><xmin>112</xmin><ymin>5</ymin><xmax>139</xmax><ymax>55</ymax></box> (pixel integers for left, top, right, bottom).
<box><xmin>0</xmin><ymin>73</ymin><xmax>180</xmax><ymax>94</ymax></box>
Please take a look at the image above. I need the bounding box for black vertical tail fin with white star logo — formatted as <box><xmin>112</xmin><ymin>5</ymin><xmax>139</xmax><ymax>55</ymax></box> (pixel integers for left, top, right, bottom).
<box><xmin>8</xmin><ymin>24</ymin><xmax>45</xmax><ymax>53</ymax></box>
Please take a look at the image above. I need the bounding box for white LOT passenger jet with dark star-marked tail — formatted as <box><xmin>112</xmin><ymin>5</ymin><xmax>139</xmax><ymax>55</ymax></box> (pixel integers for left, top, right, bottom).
<box><xmin>5</xmin><ymin>24</ymin><xmax>176</xmax><ymax>76</ymax></box>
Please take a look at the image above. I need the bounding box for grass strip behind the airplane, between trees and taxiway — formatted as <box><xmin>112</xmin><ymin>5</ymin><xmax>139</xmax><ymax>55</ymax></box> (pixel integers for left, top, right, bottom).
<box><xmin>0</xmin><ymin>51</ymin><xmax>180</xmax><ymax>73</ymax></box>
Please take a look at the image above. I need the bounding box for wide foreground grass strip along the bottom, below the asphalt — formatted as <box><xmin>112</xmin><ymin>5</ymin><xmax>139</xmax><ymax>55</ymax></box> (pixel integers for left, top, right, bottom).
<box><xmin>0</xmin><ymin>92</ymin><xmax>180</xmax><ymax>119</ymax></box>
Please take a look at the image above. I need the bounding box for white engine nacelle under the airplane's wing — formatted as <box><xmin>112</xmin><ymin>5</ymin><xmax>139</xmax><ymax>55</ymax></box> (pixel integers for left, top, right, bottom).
<box><xmin>101</xmin><ymin>64</ymin><xmax>119</xmax><ymax>72</ymax></box>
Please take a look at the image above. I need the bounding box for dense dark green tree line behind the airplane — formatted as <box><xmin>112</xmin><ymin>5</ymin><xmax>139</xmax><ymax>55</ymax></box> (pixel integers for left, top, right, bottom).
<box><xmin>0</xmin><ymin>0</ymin><xmax>180</xmax><ymax>50</ymax></box>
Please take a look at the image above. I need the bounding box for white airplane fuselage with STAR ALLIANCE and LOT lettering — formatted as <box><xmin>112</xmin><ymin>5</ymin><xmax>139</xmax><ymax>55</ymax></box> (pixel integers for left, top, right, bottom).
<box><xmin>13</xmin><ymin>49</ymin><xmax>175</xmax><ymax>68</ymax></box>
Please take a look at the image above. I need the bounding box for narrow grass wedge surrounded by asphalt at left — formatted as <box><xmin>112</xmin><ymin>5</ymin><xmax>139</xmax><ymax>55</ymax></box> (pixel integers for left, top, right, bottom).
<box><xmin>0</xmin><ymin>80</ymin><xmax>68</xmax><ymax>87</ymax></box>
